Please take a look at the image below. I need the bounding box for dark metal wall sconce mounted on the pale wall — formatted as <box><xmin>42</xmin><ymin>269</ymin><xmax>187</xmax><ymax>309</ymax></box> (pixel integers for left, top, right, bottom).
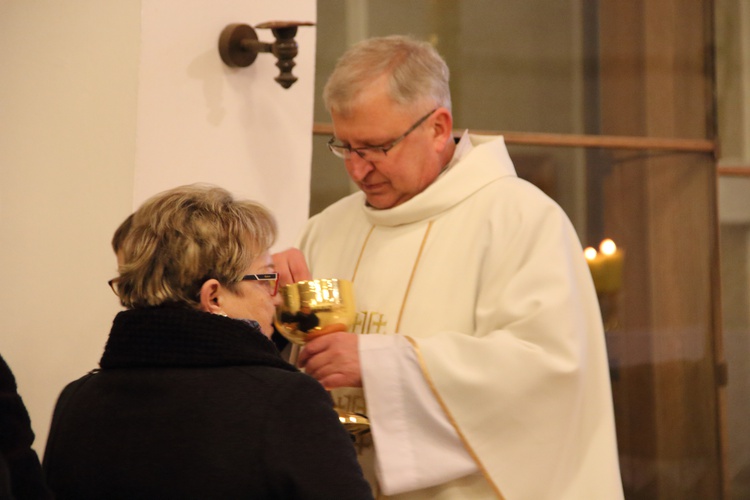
<box><xmin>219</xmin><ymin>21</ymin><xmax>313</xmax><ymax>89</ymax></box>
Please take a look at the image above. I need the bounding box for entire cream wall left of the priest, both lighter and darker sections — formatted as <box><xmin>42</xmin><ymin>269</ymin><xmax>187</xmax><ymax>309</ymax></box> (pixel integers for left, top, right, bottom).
<box><xmin>0</xmin><ymin>0</ymin><xmax>316</xmax><ymax>454</ymax></box>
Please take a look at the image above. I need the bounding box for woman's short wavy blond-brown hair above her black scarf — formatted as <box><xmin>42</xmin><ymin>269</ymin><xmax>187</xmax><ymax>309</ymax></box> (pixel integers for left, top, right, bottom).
<box><xmin>115</xmin><ymin>184</ymin><xmax>277</xmax><ymax>308</ymax></box>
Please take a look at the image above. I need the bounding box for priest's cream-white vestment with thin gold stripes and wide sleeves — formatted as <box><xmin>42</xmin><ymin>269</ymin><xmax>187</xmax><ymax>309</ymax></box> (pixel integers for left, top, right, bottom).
<box><xmin>300</xmin><ymin>134</ymin><xmax>623</xmax><ymax>500</ymax></box>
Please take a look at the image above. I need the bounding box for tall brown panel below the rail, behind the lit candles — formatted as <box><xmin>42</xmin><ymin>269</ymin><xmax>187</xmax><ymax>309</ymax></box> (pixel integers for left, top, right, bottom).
<box><xmin>536</xmin><ymin>147</ymin><xmax>721</xmax><ymax>499</ymax></box>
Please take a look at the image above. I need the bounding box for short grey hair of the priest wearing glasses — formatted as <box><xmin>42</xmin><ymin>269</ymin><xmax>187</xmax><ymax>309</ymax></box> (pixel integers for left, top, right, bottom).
<box><xmin>323</xmin><ymin>35</ymin><xmax>451</xmax><ymax>115</ymax></box>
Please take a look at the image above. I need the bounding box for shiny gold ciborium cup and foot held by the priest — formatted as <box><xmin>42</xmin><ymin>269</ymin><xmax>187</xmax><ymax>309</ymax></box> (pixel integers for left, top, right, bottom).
<box><xmin>275</xmin><ymin>279</ymin><xmax>370</xmax><ymax>438</ymax></box>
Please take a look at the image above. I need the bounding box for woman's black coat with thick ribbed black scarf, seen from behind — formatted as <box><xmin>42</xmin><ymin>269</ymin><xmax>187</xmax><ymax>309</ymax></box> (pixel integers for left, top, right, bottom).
<box><xmin>43</xmin><ymin>307</ymin><xmax>372</xmax><ymax>500</ymax></box>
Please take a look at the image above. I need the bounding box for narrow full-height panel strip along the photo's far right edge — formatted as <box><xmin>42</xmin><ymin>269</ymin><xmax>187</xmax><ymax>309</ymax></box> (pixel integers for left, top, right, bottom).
<box><xmin>715</xmin><ymin>0</ymin><xmax>750</xmax><ymax>500</ymax></box>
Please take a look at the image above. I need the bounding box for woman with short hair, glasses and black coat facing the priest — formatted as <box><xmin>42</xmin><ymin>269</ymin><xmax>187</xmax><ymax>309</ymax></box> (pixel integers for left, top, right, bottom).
<box><xmin>43</xmin><ymin>185</ymin><xmax>371</xmax><ymax>499</ymax></box>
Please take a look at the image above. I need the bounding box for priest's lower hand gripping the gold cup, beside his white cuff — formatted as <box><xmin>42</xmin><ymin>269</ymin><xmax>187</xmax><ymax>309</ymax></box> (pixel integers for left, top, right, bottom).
<box><xmin>297</xmin><ymin>332</ymin><xmax>362</xmax><ymax>389</ymax></box>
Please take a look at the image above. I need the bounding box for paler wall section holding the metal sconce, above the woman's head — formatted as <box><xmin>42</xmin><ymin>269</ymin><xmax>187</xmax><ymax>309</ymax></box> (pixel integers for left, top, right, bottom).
<box><xmin>134</xmin><ymin>0</ymin><xmax>316</xmax><ymax>242</ymax></box>
